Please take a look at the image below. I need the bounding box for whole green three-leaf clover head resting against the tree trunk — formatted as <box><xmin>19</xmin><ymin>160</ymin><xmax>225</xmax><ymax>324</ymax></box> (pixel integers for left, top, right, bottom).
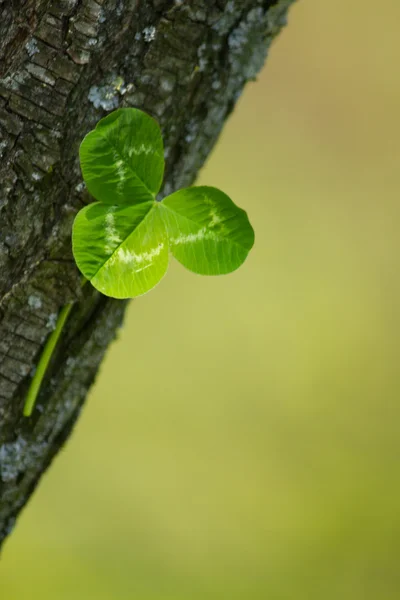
<box><xmin>72</xmin><ymin>108</ymin><xmax>254</xmax><ymax>298</ymax></box>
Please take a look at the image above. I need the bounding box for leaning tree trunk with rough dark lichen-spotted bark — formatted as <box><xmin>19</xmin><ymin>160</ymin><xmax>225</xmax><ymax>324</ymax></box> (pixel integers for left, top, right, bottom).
<box><xmin>0</xmin><ymin>0</ymin><xmax>293</xmax><ymax>544</ymax></box>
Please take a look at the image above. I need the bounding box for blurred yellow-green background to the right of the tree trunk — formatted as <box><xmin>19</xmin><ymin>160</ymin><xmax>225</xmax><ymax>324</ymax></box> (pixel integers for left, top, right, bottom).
<box><xmin>0</xmin><ymin>0</ymin><xmax>400</xmax><ymax>600</ymax></box>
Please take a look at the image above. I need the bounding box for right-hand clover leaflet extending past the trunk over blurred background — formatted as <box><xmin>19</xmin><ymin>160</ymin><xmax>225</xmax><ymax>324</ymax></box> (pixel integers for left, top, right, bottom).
<box><xmin>161</xmin><ymin>187</ymin><xmax>254</xmax><ymax>275</ymax></box>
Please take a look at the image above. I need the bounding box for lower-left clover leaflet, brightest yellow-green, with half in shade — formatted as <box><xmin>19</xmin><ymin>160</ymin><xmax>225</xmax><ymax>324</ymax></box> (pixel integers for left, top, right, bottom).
<box><xmin>72</xmin><ymin>201</ymin><xmax>169</xmax><ymax>298</ymax></box>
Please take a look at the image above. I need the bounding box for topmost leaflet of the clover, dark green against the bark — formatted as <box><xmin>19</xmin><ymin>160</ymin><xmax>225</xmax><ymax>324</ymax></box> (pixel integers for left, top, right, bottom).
<box><xmin>79</xmin><ymin>108</ymin><xmax>164</xmax><ymax>205</ymax></box>
